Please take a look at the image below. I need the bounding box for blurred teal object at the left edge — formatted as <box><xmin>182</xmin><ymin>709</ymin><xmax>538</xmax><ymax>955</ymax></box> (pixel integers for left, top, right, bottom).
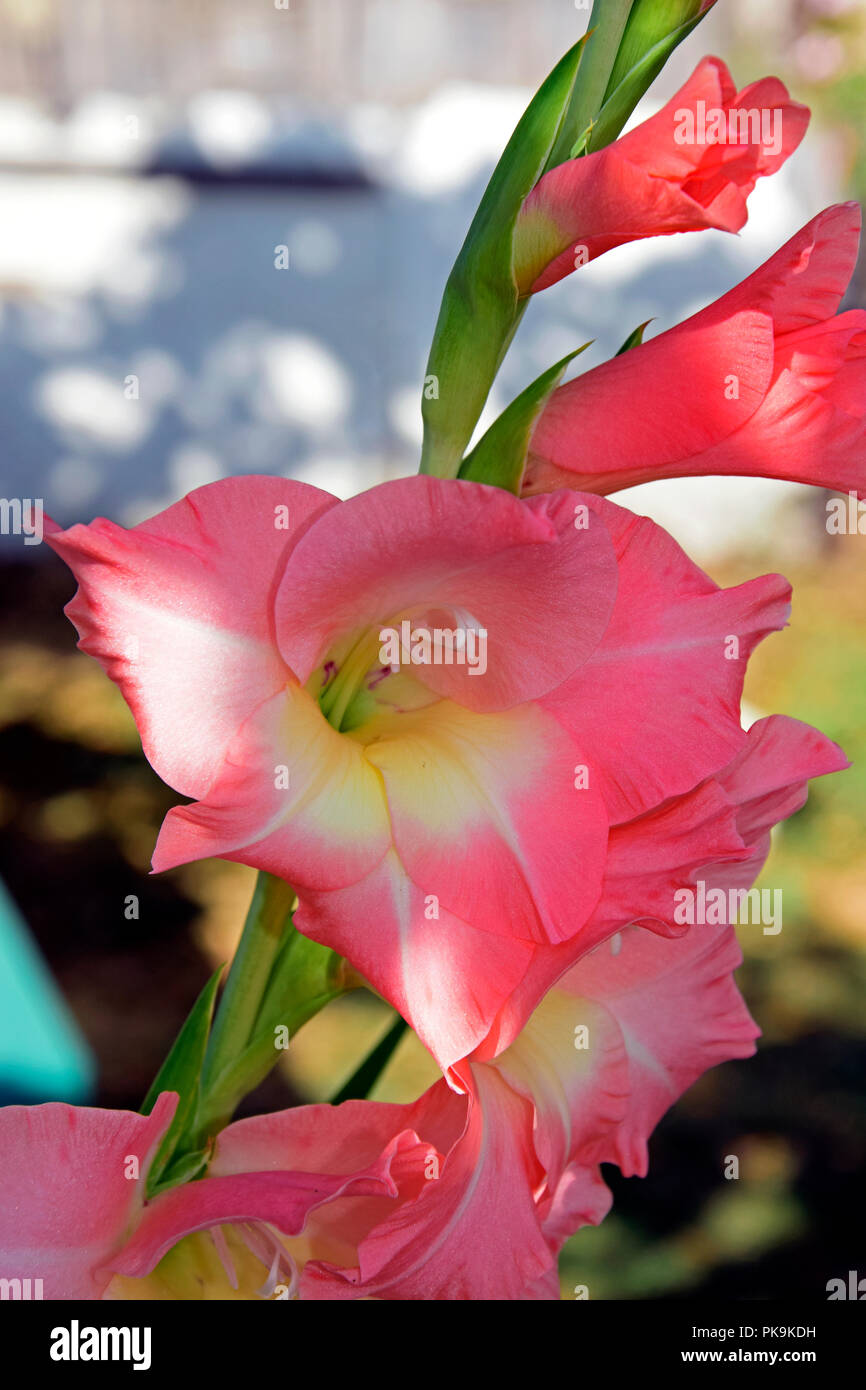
<box><xmin>0</xmin><ymin>883</ymin><xmax>96</xmax><ymax>1105</ymax></box>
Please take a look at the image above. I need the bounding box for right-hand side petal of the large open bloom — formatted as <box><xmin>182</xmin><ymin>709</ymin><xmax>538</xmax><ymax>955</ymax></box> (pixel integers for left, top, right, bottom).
<box><xmin>542</xmin><ymin>496</ymin><xmax>790</xmax><ymax>824</ymax></box>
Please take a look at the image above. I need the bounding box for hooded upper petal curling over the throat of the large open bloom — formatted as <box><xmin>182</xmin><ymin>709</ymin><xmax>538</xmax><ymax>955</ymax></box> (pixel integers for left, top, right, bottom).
<box><xmin>275</xmin><ymin>477</ymin><xmax>616</xmax><ymax>710</ymax></box>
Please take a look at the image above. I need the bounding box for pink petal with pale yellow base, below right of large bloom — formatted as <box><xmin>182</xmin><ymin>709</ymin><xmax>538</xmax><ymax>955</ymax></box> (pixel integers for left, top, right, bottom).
<box><xmin>494</xmin><ymin>927</ymin><xmax>758</xmax><ymax>1200</ymax></box>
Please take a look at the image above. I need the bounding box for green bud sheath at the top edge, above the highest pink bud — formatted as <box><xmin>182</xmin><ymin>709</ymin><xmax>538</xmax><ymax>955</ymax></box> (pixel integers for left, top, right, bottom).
<box><xmin>582</xmin><ymin>0</ymin><xmax>708</xmax><ymax>152</ymax></box>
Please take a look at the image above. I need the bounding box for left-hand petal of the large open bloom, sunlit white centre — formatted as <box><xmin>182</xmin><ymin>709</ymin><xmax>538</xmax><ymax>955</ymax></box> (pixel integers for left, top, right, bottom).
<box><xmin>46</xmin><ymin>477</ymin><xmax>336</xmax><ymax>796</ymax></box>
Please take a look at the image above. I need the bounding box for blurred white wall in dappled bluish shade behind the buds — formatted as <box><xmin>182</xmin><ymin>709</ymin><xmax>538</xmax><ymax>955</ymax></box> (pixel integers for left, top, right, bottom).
<box><xmin>0</xmin><ymin>0</ymin><xmax>844</xmax><ymax>559</ymax></box>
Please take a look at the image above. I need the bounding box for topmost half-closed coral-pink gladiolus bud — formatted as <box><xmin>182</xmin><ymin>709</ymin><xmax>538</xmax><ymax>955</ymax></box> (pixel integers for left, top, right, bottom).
<box><xmin>513</xmin><ymin>58</ymin><xmax>809</xmax><ymax>295</ymax></box>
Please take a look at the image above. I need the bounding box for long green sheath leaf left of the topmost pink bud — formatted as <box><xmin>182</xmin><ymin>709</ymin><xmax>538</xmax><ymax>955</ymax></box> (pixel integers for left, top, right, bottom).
<box><xmin>421</xmin><ymin>39</ymin><xmax>584</xmax><ymax>478</ymax></box>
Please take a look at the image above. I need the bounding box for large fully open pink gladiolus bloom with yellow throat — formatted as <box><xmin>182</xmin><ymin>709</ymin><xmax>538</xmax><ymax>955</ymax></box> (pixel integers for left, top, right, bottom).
<box><xmin>47</xmin><ymin>477</ymin><xmax>790</xmax><ymax>1070</ymax></box>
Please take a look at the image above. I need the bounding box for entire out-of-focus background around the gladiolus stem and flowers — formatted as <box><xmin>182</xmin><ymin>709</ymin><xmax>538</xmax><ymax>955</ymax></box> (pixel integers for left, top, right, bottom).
<box><xmin>0</xmin><ymin>0</ymin><xmax>866</xmax><ymax>1300</ymax></box>
